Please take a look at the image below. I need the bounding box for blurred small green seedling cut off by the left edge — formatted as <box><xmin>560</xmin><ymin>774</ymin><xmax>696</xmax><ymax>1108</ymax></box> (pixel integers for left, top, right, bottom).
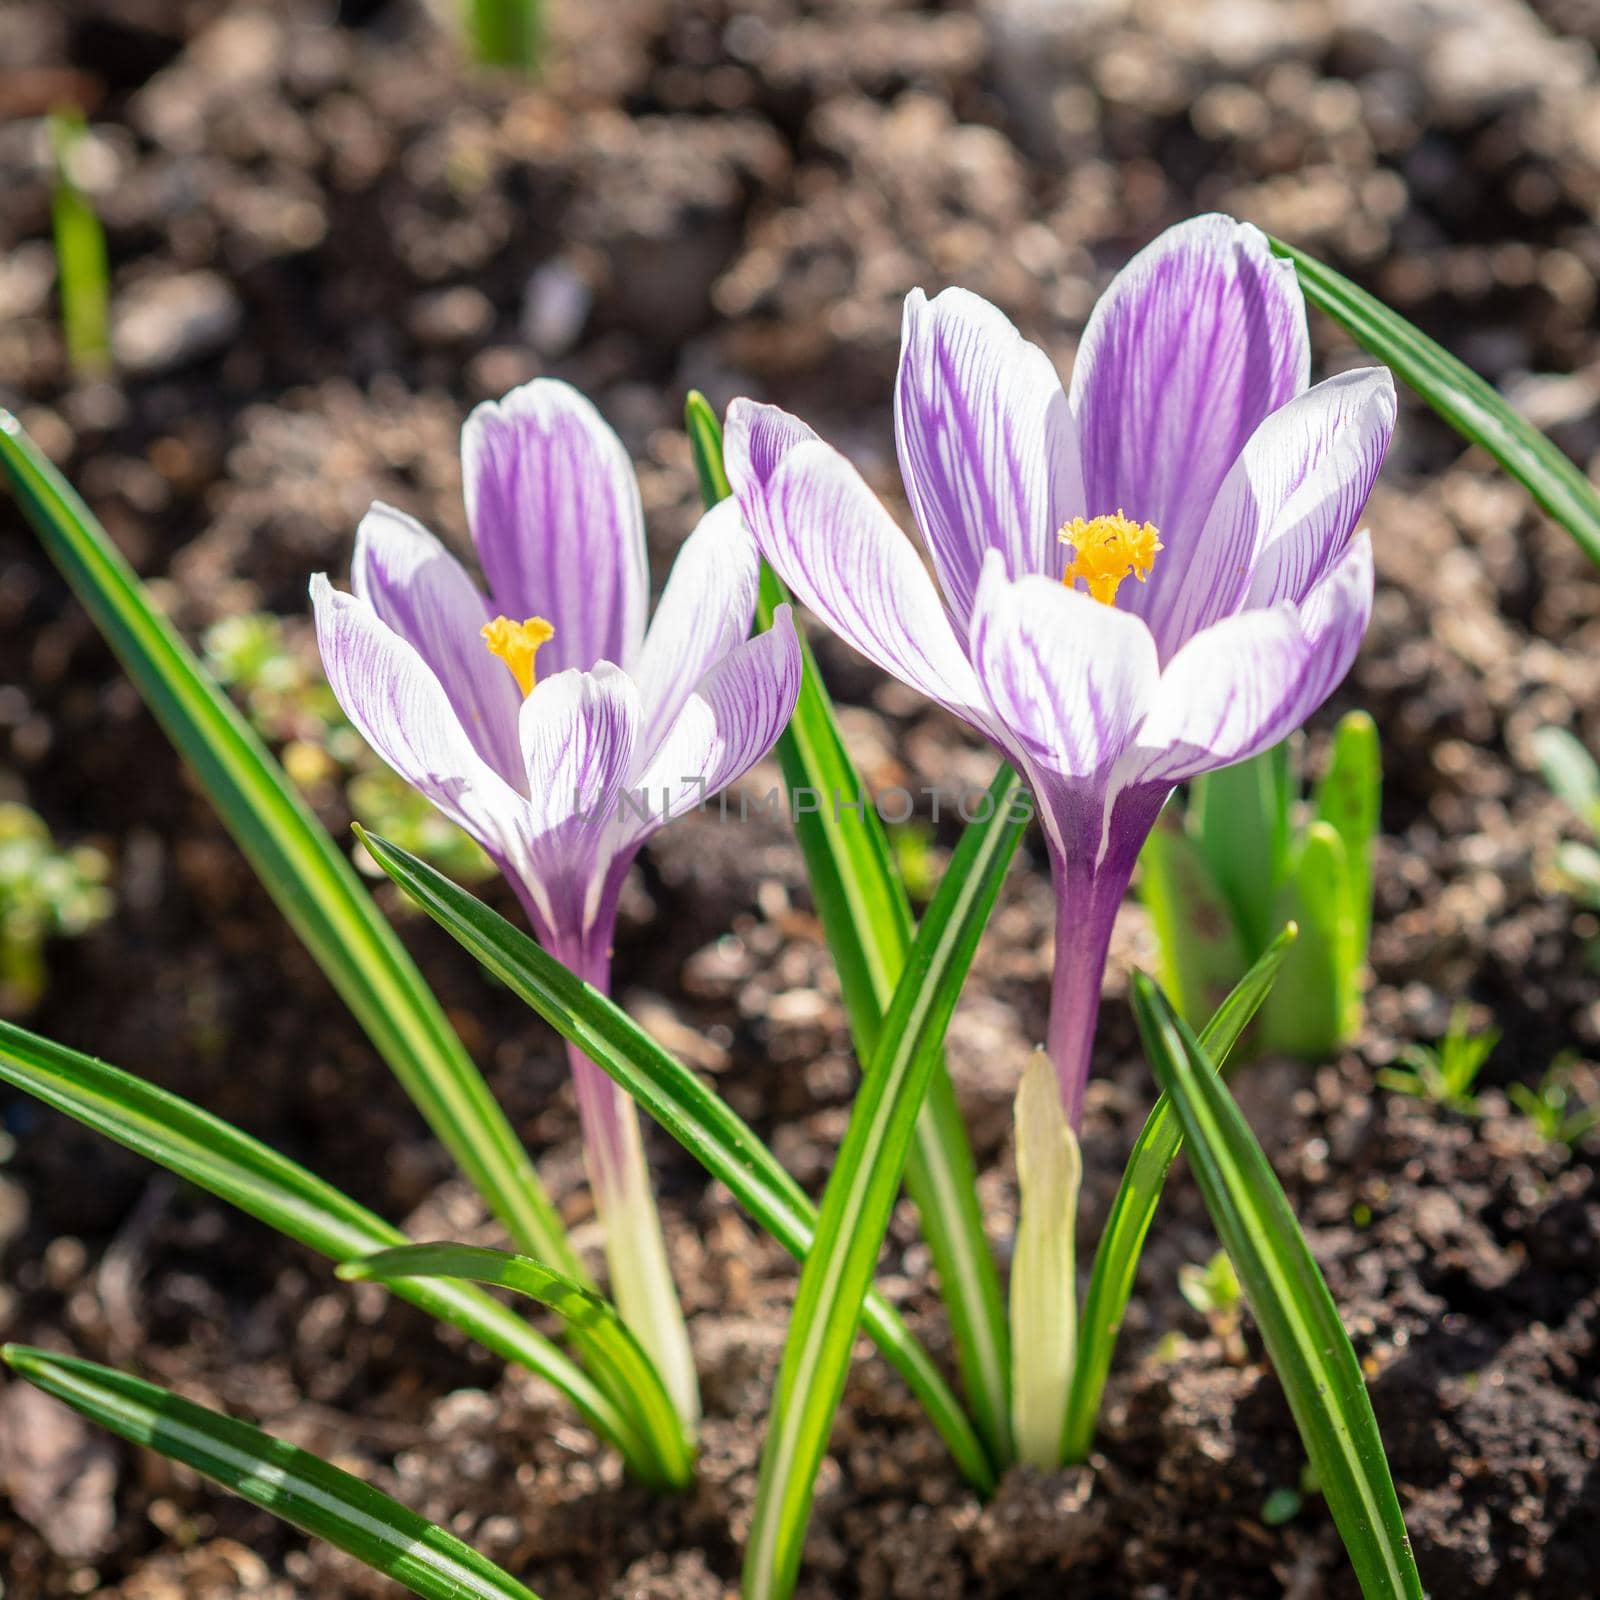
<box><xmin>0</xmin><ymin>800</ymin><xmax>114</xmax><ymax>1016</ymax></box>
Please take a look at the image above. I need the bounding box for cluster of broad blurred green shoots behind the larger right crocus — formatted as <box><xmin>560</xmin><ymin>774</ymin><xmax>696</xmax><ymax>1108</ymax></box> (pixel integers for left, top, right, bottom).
<box><xmin>1139</xmin><ymin>712</ymin><xmax>1381</xmax><ymax>1061</ymax></box>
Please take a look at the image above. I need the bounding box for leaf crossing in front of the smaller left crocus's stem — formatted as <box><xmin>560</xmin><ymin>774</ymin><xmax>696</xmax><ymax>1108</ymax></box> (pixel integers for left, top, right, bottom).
<box><xmin>357</xmin><ymin>829</ymin><xmax>995</xmax><ymax>1493</ymax></box>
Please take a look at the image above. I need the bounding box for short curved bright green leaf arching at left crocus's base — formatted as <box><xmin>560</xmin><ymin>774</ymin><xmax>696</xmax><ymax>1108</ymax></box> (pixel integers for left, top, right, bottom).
<box><xmin>338</xmin><ymin>1243</ymin><xmax>694</xmax><ymax>1486</ymax></box>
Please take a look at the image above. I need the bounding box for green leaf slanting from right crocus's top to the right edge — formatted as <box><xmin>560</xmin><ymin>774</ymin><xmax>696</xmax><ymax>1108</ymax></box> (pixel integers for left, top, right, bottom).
<box><xmin>1270</xmin><ymin>238</ymin><xmax>1600</xmax><ymax>566</ymax></box>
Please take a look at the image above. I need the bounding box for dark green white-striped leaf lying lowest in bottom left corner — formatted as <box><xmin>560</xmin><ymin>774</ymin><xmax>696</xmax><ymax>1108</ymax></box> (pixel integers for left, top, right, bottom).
<box><xmin>0</xmin><ymin>1344</ymin><xmax>538</xmax><ymax>1600</ymax></box>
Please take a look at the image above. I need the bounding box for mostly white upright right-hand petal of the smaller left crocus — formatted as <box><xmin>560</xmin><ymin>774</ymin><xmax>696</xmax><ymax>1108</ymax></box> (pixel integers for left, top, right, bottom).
<box><xmin>634</xmin><ymin>499</ymin><xmax>760</xmax><ymax>757</ymax></box>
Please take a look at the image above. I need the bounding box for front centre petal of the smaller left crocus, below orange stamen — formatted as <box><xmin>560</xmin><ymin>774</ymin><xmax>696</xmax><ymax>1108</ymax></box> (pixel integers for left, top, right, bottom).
<box><xmin>522</xmin><ymin>661</ymin><xmax>640</xmax><ymax>938</ymax></box>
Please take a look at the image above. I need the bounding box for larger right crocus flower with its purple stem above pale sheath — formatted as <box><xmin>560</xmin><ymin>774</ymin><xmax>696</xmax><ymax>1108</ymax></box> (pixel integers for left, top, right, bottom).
<box><xmin>726</xmin><ymin>216</ymin><xmax>1395</xmax><ymax>1128</ymax></box>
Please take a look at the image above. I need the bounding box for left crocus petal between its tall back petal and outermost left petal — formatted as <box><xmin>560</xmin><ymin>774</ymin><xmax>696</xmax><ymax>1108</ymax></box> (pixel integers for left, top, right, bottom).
<box><xmin>350</xmin><ymin>504</ymin><xmax>525</xmax><ymax>789</ymax></box>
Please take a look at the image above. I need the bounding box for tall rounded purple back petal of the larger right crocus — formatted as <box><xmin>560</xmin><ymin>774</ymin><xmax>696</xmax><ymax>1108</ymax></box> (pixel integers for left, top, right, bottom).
<box><xmin>1070</xmin><ymin>216</ymin><xmax>1310</xmax><ymax>638</ymax></box>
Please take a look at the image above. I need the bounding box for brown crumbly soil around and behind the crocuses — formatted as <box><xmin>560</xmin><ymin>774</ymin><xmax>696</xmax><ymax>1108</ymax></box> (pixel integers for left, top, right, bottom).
<box><xmin>0</xmin><ymin>0</ymin><xmax>1600</xmax><ymax>1600</ymax></box>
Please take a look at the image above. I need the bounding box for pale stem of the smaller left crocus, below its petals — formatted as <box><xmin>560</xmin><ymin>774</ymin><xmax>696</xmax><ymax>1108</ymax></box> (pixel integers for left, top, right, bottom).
<box><xmin>555</xmin><ymin>931</ymin><xmax>699</xmax><ymax>1429</ymax></box>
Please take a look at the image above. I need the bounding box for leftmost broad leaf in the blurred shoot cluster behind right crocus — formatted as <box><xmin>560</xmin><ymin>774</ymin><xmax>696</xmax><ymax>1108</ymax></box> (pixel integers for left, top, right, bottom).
<box><xmin>1139</xmin><ymin>816</ymin><xmax>1246</xmax><ymax>1022</ymax></box>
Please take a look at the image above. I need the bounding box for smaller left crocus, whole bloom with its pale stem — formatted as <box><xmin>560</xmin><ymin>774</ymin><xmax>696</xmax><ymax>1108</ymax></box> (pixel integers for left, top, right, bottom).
<box><xmin>312</xmin><ymin>379</ymin><xmax>800</xmax><ymax>1419</ymax></box>
